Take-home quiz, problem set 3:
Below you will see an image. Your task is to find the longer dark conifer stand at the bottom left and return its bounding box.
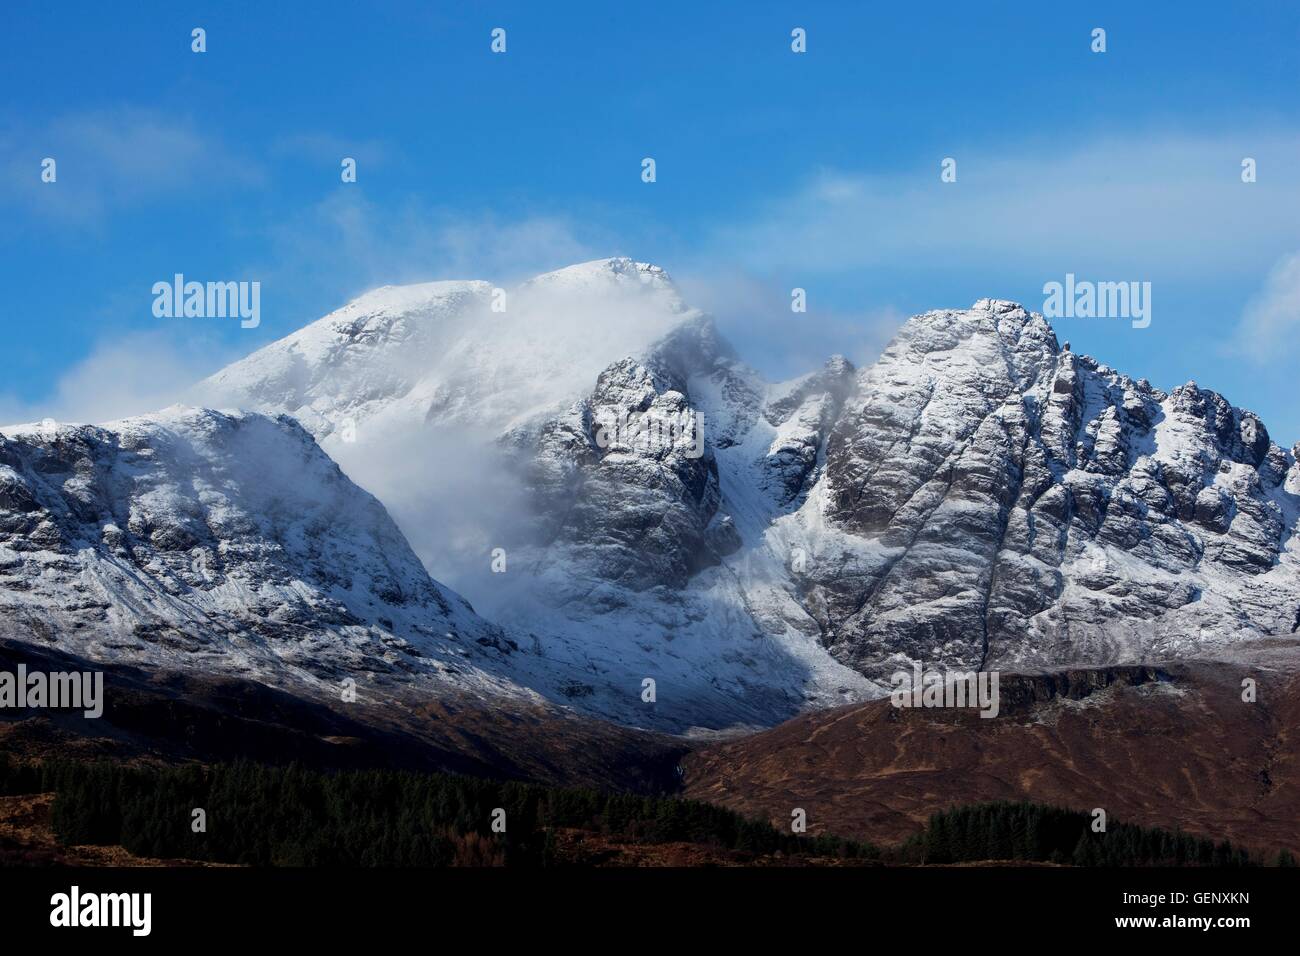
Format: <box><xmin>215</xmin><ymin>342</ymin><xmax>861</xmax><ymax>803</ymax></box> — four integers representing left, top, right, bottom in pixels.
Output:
<box><xmin>0</xmin><ymin>754</ymin><xmax>879</xmax><ymax>866</ymax></box>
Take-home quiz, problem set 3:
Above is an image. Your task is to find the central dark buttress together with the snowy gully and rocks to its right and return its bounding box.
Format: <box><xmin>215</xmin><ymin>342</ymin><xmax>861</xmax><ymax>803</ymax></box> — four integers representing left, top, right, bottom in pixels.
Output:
<box><xmin>507</xmin><ymin>316</ymin><xmax>854</xmax><ymax>600</ymax></box>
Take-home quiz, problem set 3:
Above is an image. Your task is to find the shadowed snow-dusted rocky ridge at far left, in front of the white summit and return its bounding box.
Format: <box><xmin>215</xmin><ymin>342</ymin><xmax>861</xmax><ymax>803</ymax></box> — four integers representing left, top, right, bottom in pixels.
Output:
<box><xmin>0</xmin><ymin>407</ymin><xmax>517</xmax><ymax>685</ymax></box>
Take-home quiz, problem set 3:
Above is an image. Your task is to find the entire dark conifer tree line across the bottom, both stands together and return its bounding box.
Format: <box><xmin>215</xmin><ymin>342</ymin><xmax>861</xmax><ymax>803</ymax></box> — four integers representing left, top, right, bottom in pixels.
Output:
<box><xmin>0</xmin><ymin>753</ymin><xmax>1296</xmax><ymax>866</ymax></box>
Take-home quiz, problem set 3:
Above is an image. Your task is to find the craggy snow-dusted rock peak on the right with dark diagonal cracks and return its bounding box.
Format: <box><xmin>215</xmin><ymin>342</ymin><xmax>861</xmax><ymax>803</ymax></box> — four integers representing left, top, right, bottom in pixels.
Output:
<box><xmin>806</xmin><ymin>300</ymin><xmax>1300</xmax><ymax>675</ymax></box>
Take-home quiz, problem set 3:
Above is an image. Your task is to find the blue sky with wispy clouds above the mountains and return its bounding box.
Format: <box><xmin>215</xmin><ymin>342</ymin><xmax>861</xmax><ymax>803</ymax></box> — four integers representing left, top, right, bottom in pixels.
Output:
<box><xmin>0</xmin><ymin>0</ymin><xmax>1300</xmax><ymax>445</ymax></box>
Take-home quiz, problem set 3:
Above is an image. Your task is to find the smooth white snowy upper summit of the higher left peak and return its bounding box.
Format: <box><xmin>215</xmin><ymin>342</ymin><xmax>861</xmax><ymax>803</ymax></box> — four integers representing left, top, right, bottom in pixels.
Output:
<box><xmin>194</xmin><ymin>260</ymin><xmax>692</xmax><ymax>444</ymax></box>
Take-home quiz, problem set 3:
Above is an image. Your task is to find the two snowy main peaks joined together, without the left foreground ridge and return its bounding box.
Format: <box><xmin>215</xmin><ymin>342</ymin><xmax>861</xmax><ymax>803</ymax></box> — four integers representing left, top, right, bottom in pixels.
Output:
<box><xmin>76</xmin><ymin>259</ymin><xmax>1300</xmax><ymax>731</ymax></box>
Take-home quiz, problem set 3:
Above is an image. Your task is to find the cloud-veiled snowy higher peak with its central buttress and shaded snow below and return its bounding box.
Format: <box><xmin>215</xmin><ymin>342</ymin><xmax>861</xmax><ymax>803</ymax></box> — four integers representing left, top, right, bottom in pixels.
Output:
<box><xmin>195</xmin><ymin>259</ymin><xmax>876</xmax><ymax>731</ymax></box>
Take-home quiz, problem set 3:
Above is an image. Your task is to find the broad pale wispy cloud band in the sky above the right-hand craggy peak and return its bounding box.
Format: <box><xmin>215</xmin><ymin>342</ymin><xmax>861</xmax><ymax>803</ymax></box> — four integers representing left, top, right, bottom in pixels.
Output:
<box><xmin>710</xmin><ymin>130</ymin><xmax>1300</xmax><ymax>278</ymax></box>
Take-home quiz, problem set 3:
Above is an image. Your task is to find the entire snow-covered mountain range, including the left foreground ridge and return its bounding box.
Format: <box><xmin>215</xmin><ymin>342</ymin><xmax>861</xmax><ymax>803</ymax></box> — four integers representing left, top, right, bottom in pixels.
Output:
<box><xmin>0</xmin><ymin>259</ymin><xmax>1300</xmax><ymax>731</ymax></box>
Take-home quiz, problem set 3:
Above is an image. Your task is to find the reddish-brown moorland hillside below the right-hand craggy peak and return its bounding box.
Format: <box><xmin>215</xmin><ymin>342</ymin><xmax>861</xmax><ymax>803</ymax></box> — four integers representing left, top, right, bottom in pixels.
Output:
<box><xmin>683</xmin><ymin>655</ymin><xmax>1300</xmax><ymax>852</ymax></box>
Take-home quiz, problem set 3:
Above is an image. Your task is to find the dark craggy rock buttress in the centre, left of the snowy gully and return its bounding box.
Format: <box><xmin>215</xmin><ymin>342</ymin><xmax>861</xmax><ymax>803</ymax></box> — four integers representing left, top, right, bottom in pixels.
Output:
<box><xmin>510</xmin><ymin>317</ymin><xmax>753</xmax><ymax>591</ymax></box>
